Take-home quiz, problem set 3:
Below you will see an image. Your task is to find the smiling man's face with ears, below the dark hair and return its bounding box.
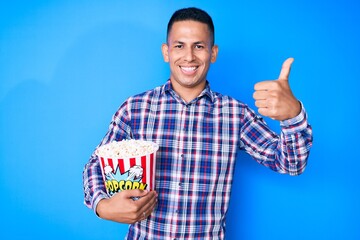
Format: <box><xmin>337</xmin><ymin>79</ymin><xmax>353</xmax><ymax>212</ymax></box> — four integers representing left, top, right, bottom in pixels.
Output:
<box><xmin>162</xmin><ymin>21</ymin><xmax>218</xmax><ymax>94</ymax></box>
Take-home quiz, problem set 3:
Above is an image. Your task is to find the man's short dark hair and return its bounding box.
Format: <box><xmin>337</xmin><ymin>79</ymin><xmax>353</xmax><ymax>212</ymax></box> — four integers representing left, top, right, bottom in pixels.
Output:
<box><xmin>166</xmin><ymin>7</ymin><xmax>215</xmax><ymax>45</ymax></box>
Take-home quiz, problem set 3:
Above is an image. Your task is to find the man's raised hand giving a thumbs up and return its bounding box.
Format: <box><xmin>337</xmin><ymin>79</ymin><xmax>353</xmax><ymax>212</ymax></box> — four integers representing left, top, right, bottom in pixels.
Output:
<box><xmin>253</xmin><ymin>58</ymin><xmax>301</xmax><ymax>121</ymax></box>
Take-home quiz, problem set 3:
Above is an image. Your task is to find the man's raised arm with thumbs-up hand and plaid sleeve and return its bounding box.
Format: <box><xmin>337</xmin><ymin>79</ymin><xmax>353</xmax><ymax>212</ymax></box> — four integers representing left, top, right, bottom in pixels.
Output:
<box><xmin>243</xmin><ymin>58</ymin><xmax>312</xmax><ymax>175</ymax></box>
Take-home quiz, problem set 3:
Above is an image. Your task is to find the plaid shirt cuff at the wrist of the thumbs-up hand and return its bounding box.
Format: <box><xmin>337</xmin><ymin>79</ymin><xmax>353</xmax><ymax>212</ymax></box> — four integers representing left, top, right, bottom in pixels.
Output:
<box><xmin>280</xmin><ymin>101</ymin><xmax>308</xmax><ymax>135</ymax></box>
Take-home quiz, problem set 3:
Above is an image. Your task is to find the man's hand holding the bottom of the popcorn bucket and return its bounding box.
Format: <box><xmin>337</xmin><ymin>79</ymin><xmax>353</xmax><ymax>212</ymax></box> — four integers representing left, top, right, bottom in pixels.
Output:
<box><xmin>96</xmin><ymin>189</ymin><xmax>157</xmax><ymax>224</ymax></box>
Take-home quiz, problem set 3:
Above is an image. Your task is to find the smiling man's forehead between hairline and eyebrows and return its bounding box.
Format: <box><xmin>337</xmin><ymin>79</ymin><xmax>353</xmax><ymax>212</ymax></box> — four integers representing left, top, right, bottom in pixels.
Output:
<box><xmin>168</xmin><ymin>20</ymin><xmax>210</xmax><ymax>42</ymax></box>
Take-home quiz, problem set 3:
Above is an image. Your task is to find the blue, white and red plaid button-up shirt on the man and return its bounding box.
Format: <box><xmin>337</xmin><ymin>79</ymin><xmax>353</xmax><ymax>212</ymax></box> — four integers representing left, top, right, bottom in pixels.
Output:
<box><xmin>83</xmin><ymin>81</ymin><xmax>312</xmax><ymax>239</ymax></box>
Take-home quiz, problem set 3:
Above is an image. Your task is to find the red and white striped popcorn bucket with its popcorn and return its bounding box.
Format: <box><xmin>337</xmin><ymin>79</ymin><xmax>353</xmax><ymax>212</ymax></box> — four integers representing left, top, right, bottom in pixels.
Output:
<box><xmin>95</xmin><ymin>140</ymin><xmax>159</xmax><ymax>197</ymax></box>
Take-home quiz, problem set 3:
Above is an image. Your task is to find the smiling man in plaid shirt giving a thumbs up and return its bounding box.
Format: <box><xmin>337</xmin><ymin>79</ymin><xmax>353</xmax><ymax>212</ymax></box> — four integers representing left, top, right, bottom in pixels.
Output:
<box><xmin>83</xmin><ymin>8</ymin><xmax>312</xmax><ymax>239</ymax></box>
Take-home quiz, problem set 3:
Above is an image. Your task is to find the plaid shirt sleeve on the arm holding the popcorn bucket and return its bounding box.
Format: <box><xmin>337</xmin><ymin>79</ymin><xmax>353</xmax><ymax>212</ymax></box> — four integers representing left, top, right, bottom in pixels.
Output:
<box><xmin>83</xmin><ymin>101</ymin><xmax>131</xmax><ymax>213</ymax></box>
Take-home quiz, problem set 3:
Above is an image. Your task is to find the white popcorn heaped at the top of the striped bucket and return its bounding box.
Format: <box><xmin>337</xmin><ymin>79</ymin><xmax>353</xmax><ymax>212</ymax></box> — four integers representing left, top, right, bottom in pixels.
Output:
<box><xmin>96</xmin><ymin>139</ymin><xmax>158</xmax><ymax>159</ymax></box>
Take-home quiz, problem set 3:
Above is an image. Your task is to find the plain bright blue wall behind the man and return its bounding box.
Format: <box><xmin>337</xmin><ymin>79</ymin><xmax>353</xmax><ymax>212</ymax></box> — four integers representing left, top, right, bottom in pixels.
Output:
<box><xmin>0</xmin><ymin>0</ymin><xmax>360</xmax><ymax>240</ymax></box>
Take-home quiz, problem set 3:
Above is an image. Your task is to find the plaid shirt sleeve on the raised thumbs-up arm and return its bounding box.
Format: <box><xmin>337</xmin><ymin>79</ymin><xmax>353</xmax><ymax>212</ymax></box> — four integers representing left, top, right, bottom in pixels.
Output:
<box><xmin>241</xmin><ymin>104</ymin><xmax>313</xmax><ymax>176</ymax></box>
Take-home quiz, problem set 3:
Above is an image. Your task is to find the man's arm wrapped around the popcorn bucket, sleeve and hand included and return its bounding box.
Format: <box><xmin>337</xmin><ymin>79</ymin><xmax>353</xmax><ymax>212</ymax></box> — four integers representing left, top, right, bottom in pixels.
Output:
<box><xmin>83</xmin><ymin>104</ymin><xmax>157</xmax><ymax>223</ymax></box>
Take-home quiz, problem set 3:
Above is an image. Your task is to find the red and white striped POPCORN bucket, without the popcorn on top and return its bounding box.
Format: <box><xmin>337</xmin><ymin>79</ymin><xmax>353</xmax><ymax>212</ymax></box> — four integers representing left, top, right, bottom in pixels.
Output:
<box><xmin>98</xmin><ymin>143</ymin><xmax>159</xmax><ymax>196</ymax></box>
